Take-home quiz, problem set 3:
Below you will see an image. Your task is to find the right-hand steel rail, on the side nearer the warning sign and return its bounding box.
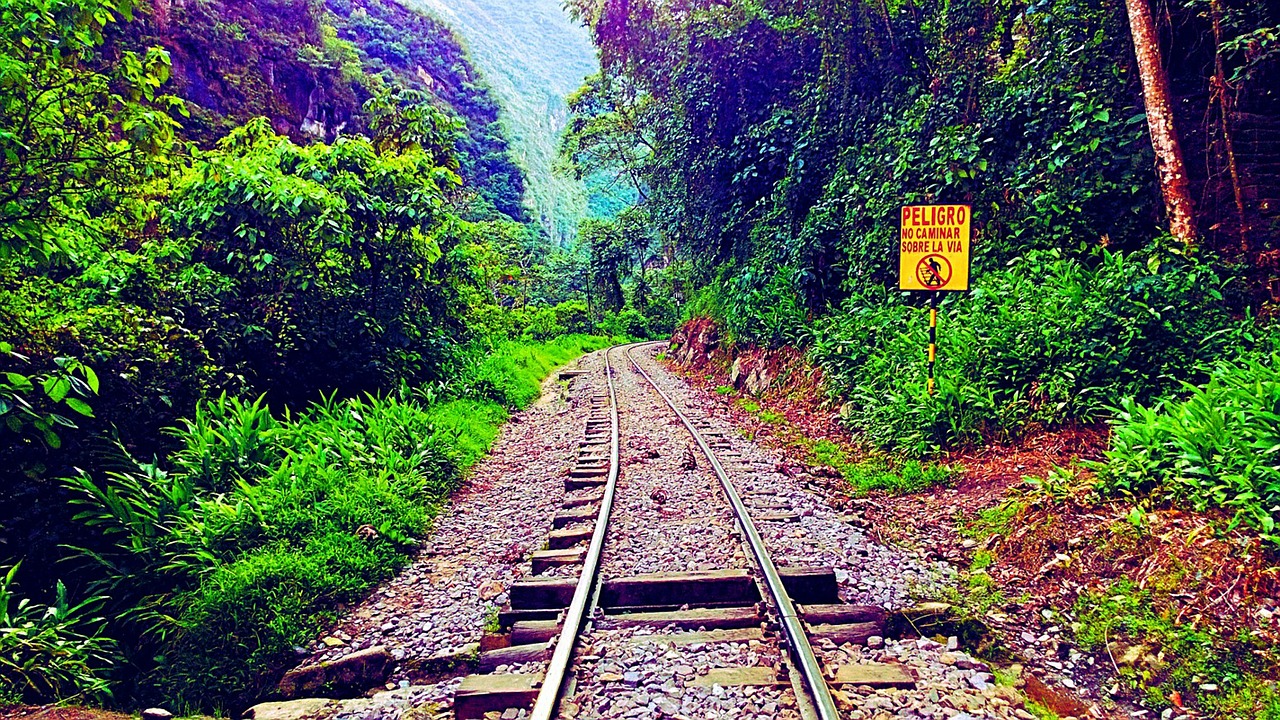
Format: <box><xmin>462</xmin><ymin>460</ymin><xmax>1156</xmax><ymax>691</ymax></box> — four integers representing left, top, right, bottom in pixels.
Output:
<box><xmin>624</xmin><ymin>343</ymin><xmax>840</xmax><ymax>720</ymax></box>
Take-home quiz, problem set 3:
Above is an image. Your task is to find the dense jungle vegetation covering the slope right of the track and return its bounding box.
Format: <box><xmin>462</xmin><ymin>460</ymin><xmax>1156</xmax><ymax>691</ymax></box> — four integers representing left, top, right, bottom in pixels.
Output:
<box><xmin>564</xmin><ymin>0</ymin><xmax>1280</xmax><ymax>542</ymax></box>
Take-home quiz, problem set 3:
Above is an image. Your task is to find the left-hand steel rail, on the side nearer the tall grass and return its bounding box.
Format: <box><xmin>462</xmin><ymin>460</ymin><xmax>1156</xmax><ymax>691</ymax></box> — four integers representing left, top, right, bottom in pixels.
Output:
<box><xmin>529</xmin><ymin>346</ymin><xmax>630</xmax><ymax>720</ymax></box>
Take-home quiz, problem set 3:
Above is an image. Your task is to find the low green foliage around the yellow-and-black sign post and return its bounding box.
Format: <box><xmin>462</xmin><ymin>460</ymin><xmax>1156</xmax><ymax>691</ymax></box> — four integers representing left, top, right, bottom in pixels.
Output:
<box><xmin>810</xmin><ymin>243</ymin><xmax>1248</xmax><ymax>454</ymax></box>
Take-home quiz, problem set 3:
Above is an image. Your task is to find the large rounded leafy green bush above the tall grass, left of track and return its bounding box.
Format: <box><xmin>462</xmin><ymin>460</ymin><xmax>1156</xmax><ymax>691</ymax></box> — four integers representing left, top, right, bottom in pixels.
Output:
<box><xmin>170</xmin><ymin>114</ymin><xmax>461</xmax><ymax>402</ymax></box>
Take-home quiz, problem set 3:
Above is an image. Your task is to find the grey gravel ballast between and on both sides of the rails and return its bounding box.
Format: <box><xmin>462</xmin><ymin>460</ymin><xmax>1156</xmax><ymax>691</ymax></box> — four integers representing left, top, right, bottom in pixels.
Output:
<box><xmin>294</xmin><ymin>347</ymin><xmax>1032</xmax><ymax>720</ymax></box>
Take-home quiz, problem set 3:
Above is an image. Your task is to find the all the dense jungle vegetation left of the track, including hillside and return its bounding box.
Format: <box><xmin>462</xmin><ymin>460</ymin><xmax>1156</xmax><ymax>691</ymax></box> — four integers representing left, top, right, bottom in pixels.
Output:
<box><xmin>0</xmin><ymin>0</ymin><xmax>675</xmax><ymax>711</ymax></box>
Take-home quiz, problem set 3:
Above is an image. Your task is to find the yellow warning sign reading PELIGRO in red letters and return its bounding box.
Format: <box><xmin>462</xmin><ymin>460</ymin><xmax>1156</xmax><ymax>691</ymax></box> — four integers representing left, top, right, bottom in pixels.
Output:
<box><xmin>897</xmin><ymin>205</ymin><xmax>973</xmax><ymax>290</ymax></box>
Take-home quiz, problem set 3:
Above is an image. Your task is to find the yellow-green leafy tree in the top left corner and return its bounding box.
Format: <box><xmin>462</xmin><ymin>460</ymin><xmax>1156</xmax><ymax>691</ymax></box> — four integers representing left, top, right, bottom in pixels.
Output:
<box><xmin>0</xmin><ymin>0</ymin><xmax>186</xmax><ymax>258</ymax></box>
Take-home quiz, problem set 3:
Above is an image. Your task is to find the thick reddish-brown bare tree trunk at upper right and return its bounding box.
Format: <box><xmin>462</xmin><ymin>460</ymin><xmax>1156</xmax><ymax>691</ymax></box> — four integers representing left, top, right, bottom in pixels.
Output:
<box><xmin>1125</xmin><ymin>0</ymin><xmax>1196</xmax><ymax>246</ymax></box>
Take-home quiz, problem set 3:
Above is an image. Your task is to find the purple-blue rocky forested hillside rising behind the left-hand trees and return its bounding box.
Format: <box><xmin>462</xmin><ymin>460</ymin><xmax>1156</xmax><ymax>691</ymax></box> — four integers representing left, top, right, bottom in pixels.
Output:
<box><xmin>106</xmin><ymin>0</ymin><xmax>526</xmax><ymax>220</ymax></box>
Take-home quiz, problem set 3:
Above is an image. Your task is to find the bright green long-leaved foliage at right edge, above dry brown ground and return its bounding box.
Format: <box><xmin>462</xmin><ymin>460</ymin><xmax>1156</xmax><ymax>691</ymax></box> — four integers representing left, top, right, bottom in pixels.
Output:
<box><xmin>1097</xmin><ymin>340</ymin><xmax>1280</xmax><ymax>543</ymax></box>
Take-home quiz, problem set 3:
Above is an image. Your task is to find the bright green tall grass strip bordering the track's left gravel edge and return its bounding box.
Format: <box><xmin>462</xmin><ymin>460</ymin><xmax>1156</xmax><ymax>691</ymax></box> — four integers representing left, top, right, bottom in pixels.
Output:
<box><xmin>45</xmin><ymin>336</ymin><xmax>608</xmax><ymax>710</ymax></box>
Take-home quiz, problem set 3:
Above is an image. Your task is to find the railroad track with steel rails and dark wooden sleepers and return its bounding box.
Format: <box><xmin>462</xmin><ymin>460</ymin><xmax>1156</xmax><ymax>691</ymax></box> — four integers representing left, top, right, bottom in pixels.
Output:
<box><xmin>454</xmin><ymin>343</ymin><xmax>913</xmax><ymax>720</ymax></box>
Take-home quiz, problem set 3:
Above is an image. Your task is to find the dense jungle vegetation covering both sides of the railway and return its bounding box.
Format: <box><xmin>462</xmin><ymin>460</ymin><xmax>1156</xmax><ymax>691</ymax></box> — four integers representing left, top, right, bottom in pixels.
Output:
<box><xmin>0</xmin><ymin>0</ymin><xmax>1280</xmax><ymax>711</ymax></box>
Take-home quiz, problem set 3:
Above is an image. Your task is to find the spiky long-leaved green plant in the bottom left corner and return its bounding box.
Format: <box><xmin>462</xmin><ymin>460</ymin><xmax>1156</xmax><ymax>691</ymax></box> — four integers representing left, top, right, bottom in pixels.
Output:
<box><xmin>0</xmin><ymin>565</ymin><xmax>118</xmax><ymax>703</ymax></box>
